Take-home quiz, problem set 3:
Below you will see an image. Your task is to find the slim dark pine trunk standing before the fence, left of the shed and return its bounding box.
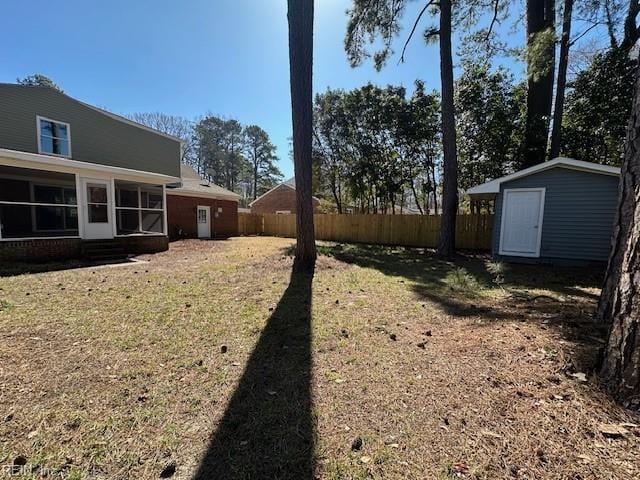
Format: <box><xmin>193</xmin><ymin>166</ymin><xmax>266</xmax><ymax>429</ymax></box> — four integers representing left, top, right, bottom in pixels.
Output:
<box><xmin>438</xmin><ymin>0</ymin><xmax>458</xmax><ymax>257</ymax></box>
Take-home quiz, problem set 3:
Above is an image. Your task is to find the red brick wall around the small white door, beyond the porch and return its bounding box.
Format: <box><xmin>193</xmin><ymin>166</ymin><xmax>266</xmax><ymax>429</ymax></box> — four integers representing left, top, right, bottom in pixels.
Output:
<box><xmin>167</xmin><ymin>195</ymin><xmax>238</xmax><ymax>240</ymax></box>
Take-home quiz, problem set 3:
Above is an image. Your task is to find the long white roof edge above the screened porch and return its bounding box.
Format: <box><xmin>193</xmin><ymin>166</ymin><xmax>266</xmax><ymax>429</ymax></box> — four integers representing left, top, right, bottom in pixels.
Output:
<box><xmin>0</xmin><ymin>148</ymin><xmax>180</xmax><ymax>185</ymax></box>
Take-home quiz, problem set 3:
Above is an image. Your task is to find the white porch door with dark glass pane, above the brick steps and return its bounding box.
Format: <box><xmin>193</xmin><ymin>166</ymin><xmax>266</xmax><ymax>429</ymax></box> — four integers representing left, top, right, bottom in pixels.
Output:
<box><xmin>80</xmin><ymin>178</ymin><xmax>113</xmax><ymax>240</ymax></box>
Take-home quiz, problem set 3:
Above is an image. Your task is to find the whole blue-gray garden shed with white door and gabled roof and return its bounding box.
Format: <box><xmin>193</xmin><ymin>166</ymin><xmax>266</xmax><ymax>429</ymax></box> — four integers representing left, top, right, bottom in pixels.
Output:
<box><xmin>467</xmin><ymin>158</ymin><xmax>620</xmax><ymax>264</ymax></box>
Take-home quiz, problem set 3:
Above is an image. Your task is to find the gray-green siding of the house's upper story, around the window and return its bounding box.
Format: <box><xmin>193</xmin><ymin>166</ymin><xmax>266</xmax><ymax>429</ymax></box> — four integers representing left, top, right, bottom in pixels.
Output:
<box><xmin>0</xmin><ymin>84</ymin><xmax>180</xmax><ymax>177</ymax></box>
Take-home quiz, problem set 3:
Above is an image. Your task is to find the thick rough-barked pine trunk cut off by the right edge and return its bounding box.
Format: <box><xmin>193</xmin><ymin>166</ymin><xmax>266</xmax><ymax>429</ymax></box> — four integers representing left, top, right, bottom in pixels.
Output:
<box><xmin>598</xmin><ymin>57</ymin><xmax>640</xmax><ymax>408</ymax></box>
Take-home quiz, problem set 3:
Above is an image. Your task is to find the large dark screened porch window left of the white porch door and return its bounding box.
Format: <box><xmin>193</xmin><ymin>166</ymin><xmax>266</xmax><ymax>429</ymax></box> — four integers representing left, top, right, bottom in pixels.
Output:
<box><xmin>0</xmin><ymin>167</ymin><xmax>78</xmax><ymax>239</ymax></box>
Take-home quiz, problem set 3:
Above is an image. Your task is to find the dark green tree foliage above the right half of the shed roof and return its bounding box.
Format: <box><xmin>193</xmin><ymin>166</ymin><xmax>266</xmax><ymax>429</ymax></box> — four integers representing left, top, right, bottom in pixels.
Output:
<box><xmin>561</xmin><ymin>48</ymin><xmax>636</xmax><ymax>165</ymax></box>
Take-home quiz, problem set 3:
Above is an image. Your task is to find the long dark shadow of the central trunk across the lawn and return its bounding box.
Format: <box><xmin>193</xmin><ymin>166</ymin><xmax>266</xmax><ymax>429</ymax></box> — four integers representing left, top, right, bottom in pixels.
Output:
<box><xmin>193</xmin><ymin>266</ymin><xmax>315</xmax><ymax>480</ymax></box>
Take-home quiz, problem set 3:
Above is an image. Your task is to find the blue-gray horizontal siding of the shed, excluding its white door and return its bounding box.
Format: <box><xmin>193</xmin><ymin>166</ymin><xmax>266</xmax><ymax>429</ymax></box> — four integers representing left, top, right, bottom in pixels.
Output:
<box><xmin>493</xmin><ymin>167</ymin><xmax>619</xmax><ymax>263</ymax></box>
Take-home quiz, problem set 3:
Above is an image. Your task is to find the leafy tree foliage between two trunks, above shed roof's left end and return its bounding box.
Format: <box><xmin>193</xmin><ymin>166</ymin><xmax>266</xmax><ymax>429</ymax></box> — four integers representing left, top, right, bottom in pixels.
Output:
<box><xmin>455</xmin><ymin>60</ymin><xmax>526</xmax><ymax>189</ymax></box>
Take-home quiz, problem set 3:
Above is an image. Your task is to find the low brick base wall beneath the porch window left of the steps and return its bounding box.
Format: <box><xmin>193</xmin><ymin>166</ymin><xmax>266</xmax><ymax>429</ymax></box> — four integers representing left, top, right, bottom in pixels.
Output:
<box><xmin>0</xmin><ymin>238</ymin><xmax>82</xmax><ymax>262</ymax></box>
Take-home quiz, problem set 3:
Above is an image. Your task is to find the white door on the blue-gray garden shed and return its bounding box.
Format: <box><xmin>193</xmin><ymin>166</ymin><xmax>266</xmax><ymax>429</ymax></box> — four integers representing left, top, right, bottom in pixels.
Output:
<box><xmin>500</xmin><ymin>188</ymin><xmax>545</xmax><ymax>257</ymax></box>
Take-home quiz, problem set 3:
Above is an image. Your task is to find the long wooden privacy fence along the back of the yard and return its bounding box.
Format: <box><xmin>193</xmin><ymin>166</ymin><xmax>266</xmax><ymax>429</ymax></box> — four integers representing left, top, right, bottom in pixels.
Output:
<box><xmin>238</xmin><ymin>213</ymin><xmax>493</xmax><ymax>250</ymax></box>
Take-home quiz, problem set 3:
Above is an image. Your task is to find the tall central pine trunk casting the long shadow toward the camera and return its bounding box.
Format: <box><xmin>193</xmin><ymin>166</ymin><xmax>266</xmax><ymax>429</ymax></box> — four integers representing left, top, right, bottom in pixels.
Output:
<box><xmin>288</xmin><ymin>0</ymin><xmax>317</xmax><ymax>270</ymax></box>
